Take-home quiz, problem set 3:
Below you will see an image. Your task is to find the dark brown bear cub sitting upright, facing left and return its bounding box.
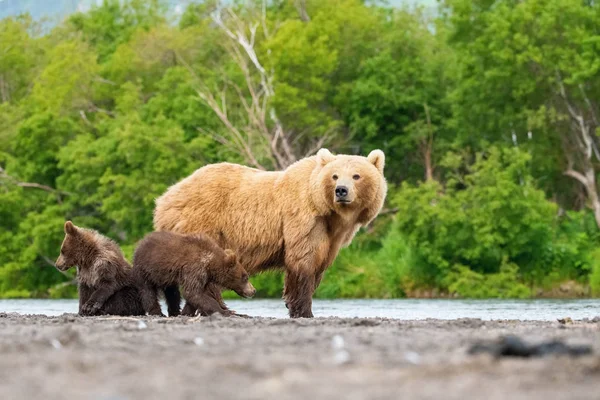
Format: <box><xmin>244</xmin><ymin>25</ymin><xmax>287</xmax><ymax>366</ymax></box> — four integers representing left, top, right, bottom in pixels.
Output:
<box><xmin>55</xmin><ymin>221</ymin><xmax>144</xmax><ymax>316</ymax></box>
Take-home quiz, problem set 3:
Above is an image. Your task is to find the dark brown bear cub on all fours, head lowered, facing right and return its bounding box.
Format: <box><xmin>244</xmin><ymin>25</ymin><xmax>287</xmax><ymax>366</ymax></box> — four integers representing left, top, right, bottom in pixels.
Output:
<box><xmin>133</xmin><ymin>232</ymin><xmax>256</xmax><ymax>316</ymax></box>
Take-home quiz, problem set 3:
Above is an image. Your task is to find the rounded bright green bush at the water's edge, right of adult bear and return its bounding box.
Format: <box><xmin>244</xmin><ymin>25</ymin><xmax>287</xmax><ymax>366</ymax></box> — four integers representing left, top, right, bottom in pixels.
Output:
<box><xmin>392</xmin><ymin>148</ymin><xmax>557</xmax><ymax>297</ymax></box>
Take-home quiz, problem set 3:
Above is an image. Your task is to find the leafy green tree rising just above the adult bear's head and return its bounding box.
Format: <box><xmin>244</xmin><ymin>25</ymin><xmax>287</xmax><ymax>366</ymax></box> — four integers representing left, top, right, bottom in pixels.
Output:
<box><xmin>342</xmin><ymin>10</ymin><xmax>454</xmax><ymax>180</ymax></box>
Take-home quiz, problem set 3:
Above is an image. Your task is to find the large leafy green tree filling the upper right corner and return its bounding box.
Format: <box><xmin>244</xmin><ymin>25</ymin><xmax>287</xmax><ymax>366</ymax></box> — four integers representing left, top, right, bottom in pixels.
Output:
<box><xmin>446</xmin><ymin>0</ymin><xmax>600</xmax><ymax>227</ymax></box>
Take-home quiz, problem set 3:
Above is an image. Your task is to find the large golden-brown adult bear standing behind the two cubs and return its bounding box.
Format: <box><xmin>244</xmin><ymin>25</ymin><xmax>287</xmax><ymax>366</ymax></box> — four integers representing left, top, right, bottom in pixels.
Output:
<box><xmin>154</xmin><ymin>149</ymin><xmax>387</xmax><ymax>318</ymax></box>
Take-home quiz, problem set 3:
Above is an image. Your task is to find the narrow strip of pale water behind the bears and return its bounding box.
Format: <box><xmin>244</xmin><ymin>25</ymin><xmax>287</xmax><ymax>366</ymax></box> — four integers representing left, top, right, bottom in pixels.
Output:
<box><xmin>0</xmin><ymin>299</ymin><xmax>600</xmax><ymax>321</ymax></box>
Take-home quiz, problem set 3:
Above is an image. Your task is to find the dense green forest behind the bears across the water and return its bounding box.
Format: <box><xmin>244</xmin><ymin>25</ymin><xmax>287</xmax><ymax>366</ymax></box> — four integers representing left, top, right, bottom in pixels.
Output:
<box><xmin>0</xmin><ymin>0</ymin><xmax>600</xmax><ymax>298</ymax></box>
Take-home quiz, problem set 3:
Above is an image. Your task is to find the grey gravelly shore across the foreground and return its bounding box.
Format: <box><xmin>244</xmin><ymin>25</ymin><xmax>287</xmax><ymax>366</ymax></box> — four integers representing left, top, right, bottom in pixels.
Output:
<box><xmin>0</xmin><ymin>313</ymin><xmax>600</xmax><ymax>400</ymax></box>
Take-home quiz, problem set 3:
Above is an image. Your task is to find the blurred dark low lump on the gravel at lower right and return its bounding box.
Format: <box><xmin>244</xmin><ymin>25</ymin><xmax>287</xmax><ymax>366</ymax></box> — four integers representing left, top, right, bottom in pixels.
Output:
<box><xmin>468</xmin><ymin>336</ymin><xmax>593</xmax><ymax>358</ymax></box>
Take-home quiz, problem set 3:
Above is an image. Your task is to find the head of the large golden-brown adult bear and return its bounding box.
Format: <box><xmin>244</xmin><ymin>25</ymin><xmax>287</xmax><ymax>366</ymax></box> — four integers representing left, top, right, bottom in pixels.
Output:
<box><xmin>311</xmin><ymin>149</ymin><xmax>387</xmax><ymax>214</ymax></box>
